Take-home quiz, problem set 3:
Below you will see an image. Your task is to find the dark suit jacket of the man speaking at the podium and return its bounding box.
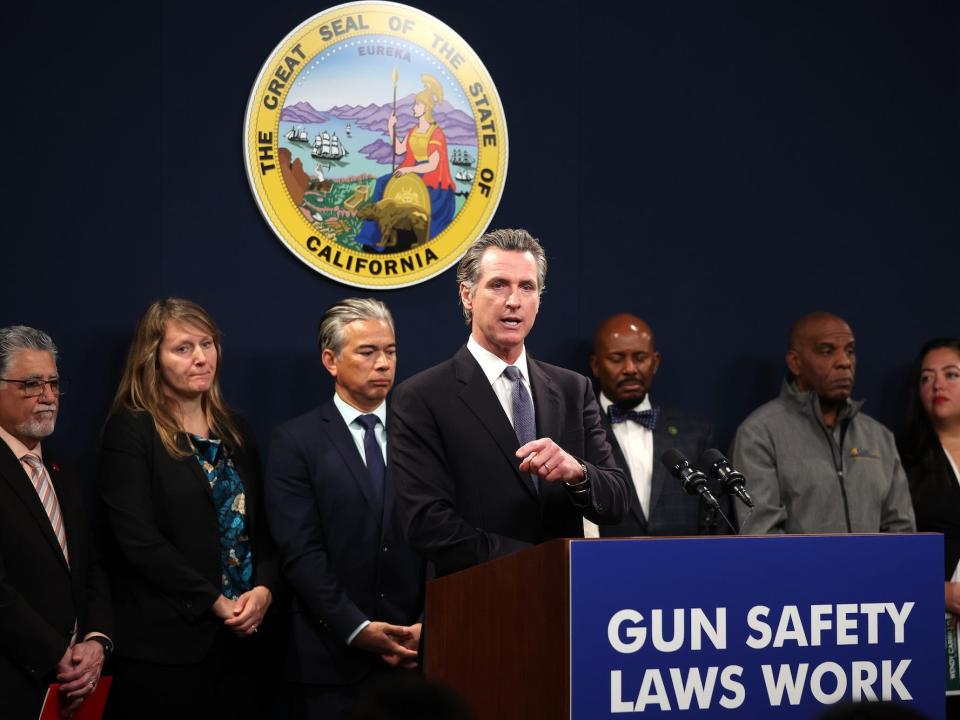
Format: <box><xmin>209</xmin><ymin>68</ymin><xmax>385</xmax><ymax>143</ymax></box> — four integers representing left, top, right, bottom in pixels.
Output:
<box><xmin>390</xmin><ymin>347</ymin><xmax>627</xmax><ymax>575</ymax></box>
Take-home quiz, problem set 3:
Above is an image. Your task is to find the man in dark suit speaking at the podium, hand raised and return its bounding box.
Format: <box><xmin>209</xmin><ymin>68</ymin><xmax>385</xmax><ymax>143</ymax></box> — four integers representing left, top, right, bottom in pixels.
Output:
<box><xmin>389</xmin><ymin>230</ymin><xmax>628</xmax><ymax>575</ymax></box>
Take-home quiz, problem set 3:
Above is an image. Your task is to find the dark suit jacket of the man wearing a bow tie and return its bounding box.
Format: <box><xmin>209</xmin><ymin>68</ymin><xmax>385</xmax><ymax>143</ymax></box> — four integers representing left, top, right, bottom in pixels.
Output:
<box><xmin>600</xmin><ymin>407</ymin><xmax>732</xmax><ymax>537</ymax></box>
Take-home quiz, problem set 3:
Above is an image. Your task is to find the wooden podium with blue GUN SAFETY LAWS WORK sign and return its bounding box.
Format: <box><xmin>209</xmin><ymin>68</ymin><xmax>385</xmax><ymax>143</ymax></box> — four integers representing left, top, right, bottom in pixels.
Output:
<box><xmin>424</xmin><ymin>534</ymin><xmax>945</xmax><ymax>720</ymax></box>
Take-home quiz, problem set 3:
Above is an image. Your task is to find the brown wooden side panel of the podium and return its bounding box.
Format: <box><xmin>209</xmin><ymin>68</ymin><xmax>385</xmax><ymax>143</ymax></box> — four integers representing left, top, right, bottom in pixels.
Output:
<box><xmin>424</xmin><ymin>540</ymin><xmax>570</xmax><ymax>720</ymax></box>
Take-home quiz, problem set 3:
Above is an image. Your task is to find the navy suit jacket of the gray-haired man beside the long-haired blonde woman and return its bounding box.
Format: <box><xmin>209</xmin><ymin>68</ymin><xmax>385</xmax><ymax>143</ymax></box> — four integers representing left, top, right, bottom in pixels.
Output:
<box><xmin>266</xmin><ymin>400</ymin><xmax>424</xmax><ymax>686</ymax></box>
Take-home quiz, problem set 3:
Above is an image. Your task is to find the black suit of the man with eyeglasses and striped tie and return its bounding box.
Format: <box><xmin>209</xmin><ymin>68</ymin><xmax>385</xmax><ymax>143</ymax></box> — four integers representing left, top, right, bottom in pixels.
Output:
<box><xmin>0</xmin><ymin>440</ymin><xmax>113</xmax><ymax>720</ymax></box>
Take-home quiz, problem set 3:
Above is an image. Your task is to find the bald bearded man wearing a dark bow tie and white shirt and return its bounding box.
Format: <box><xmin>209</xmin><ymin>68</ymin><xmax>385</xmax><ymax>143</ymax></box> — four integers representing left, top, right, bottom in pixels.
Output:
<box><xmin>584</xmin><ymin>313</ymin><xmax>732</xmax><ymax>537</ymax></box>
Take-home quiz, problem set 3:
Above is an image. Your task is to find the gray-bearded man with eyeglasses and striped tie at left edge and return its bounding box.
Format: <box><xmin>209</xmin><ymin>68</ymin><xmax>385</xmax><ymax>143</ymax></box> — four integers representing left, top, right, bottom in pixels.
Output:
<box><xmin>0</xmin><ymin>325</ymin><xmax>113</xmax><ymax>718</ymax></box>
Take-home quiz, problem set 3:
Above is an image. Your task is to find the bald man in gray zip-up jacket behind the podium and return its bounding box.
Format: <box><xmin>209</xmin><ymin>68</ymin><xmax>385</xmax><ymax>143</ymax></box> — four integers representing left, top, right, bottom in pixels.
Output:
<box><xmin>731</xmin><ymin>313</ymin><xmax>916</xmax><ymax>535</ymax></box>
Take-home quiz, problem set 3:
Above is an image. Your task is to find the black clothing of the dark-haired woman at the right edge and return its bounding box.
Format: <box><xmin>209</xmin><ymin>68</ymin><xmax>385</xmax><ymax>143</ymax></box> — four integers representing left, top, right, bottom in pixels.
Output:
<box><xmin>907</xmin><ymin>446</ymin><xmax>960</xmax><ymax>580</ymax></box>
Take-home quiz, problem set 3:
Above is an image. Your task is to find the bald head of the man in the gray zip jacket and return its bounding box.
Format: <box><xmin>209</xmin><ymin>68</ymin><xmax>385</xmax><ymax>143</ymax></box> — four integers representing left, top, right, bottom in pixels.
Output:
<box><xmin>786</xmin><ymin>312</ymin><xmax>857</xmax><ymax>406</ymax></box>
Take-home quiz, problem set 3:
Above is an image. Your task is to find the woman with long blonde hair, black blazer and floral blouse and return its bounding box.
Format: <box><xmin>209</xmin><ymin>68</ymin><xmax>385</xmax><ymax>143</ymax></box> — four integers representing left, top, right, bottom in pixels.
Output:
<box><xmin>98</xmin><ymin>298</ymin><xmax>277</xmax><ymax>720</ymax></box>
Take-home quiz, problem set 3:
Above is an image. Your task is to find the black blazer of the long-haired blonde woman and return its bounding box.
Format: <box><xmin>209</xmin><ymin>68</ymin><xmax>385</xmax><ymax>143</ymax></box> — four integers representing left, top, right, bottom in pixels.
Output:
<box><xmin>98</xmin><ymin>410</ymin><xmax>278</xmax><ymax>664</ymax></box>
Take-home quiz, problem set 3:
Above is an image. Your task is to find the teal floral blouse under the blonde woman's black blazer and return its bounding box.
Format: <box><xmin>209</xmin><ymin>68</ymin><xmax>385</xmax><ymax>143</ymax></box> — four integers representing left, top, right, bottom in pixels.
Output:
<box><xmin>190</xmin><ymin>434</ymin><xmax>253</xmax><ymax>600</ymax></box>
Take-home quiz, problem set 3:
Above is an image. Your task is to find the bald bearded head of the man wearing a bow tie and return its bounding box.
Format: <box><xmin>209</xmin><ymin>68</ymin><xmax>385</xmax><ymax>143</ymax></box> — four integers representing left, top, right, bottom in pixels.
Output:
<box><xmin>590</xmin><ymin>313</ymin><xmax>660</xmax><ymax>408</ymax></box>
